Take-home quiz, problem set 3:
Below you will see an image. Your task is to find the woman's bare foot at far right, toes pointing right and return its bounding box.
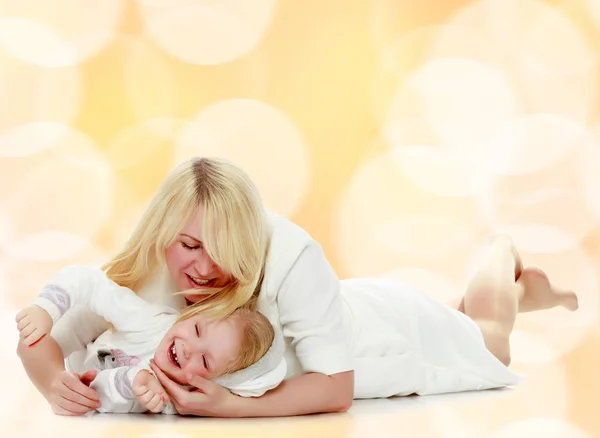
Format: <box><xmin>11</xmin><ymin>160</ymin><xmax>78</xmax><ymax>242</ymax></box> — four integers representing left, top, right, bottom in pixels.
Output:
<box><xmin>518</xmin><ymin>268</ymin><xmax>579</xmax><ymax>313</ymax></box>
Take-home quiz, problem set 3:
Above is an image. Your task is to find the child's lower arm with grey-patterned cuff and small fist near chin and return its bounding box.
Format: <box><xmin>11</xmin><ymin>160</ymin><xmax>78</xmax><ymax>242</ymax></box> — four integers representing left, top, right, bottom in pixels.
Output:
<box><xmin>90</xmin><ymin>366</ymin><xmax>177</xmax><ymax>414</ymax></box>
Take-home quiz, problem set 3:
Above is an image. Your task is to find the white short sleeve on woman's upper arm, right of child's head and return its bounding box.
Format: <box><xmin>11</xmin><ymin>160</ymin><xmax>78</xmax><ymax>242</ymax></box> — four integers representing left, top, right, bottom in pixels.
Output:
<box><xmin>277</xmin><ymin>243</ymin><xmax>353</xmax><ymax>375</ymax></box>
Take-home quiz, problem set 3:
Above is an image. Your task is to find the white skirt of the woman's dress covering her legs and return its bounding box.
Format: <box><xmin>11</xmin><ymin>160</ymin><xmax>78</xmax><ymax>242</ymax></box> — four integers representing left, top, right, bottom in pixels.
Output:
<box><xmin>341</xmin><ymin>279</ymin><xmax>521</xmax><ymax>398</ymax></box>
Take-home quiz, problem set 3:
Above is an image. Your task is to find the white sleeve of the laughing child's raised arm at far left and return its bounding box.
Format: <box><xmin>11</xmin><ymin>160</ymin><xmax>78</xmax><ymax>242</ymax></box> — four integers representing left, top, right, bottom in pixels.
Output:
<box><xmin>33</xmin><ymin>266</ymin><xmax>172</xmax><ymax>331</ymax></box>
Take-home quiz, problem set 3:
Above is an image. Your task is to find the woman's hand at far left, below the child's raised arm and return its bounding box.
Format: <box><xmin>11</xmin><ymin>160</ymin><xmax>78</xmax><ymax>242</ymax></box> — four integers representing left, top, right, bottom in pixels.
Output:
<box><xmin>44</xmin><ymin>370</ymin><xmax>100</xmax><ymax>415</ymax></box>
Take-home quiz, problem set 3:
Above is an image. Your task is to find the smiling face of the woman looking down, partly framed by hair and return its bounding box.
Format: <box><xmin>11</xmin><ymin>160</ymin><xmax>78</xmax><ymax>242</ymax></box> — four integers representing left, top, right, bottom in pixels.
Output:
<box><xmin>166</xmin><ymin>207</ymin><xmax>231</xmax><ymax>302</ymax></box>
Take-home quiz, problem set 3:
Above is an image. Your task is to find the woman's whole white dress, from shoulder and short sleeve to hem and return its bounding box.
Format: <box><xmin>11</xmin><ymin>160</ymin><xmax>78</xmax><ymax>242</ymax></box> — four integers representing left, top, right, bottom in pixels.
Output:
<box><xmin>47</xmin><ymin>215</ymin><xmax>520</xmax><ymax>404</ymax></box>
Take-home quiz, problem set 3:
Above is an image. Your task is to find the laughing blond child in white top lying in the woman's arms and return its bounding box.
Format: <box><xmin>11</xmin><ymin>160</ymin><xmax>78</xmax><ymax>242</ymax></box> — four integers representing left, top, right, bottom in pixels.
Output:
<box><xmin>16</xmin><ymin>266</ymin><xmax>286</xmax><ymax>414</ymax></box>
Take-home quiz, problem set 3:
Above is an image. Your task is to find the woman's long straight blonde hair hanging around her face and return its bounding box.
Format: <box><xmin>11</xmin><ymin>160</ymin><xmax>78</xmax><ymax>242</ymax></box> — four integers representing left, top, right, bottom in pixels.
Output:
<box><xmin>103</xmin><ymin>158</ymin><xmax>271</xmax><ymax>317</ymax></box>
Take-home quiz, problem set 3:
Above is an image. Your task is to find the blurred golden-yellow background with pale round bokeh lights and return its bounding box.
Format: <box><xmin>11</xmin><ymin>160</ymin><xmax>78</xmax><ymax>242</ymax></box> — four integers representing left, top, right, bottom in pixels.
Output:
<box><xmin>0</xmin><ymin>0</ymin><xmax>600</xmax><ymax>437</ymax></box>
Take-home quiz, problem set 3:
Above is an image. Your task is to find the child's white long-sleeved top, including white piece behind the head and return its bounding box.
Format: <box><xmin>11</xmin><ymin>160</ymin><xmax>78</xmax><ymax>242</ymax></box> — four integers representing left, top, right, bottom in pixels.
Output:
<box><xmin>33</xmin><ymin>266</ymin><xmax>286</xmax><ymax>414</ymax></box>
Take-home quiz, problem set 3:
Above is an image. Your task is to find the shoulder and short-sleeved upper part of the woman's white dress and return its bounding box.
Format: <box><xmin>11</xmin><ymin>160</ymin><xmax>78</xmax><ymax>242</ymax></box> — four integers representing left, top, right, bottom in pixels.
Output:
<box><xmin>257</xmin><ymin>215</ymin><xmax>353</xmax><ymax>378</ymax></box>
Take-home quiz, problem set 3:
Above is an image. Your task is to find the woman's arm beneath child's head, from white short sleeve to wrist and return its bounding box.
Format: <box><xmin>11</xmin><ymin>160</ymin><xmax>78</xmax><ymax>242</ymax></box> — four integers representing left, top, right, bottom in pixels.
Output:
<box><xmin>258</xmin><ymin>243</ymin><xmax>354</xmax><ymax>416</ymax></box>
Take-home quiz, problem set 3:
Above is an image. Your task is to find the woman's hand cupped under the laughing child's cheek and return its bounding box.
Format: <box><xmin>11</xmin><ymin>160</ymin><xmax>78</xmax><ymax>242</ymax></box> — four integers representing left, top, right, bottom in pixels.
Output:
<box><xmin>150</xmin><ymin>361</ymin><xmax>238</xmax><ymax>417</ymax></box>
